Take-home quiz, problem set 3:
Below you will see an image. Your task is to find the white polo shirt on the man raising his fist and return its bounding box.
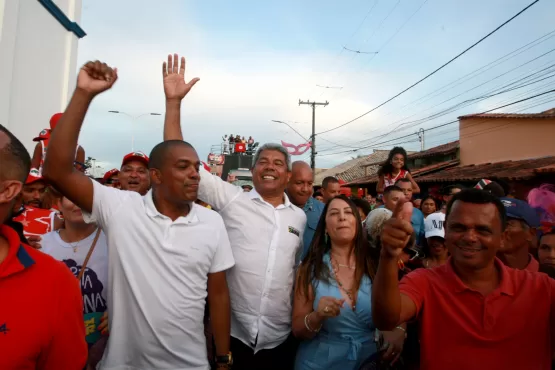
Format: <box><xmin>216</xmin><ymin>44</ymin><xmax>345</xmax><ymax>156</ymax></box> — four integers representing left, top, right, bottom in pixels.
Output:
<box><xmin>85</xmin><ymin>181</ymin><xmax>235</xmax><ymax>370</ymax></box>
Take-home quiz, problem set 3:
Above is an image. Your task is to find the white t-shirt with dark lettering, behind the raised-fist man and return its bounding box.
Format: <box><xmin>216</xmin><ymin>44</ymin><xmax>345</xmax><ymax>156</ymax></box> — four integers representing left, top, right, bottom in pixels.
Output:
<box><xmin>41</xmin><ymin>231</ymin><xmax>108</xmax><ymax>344</ymax></box>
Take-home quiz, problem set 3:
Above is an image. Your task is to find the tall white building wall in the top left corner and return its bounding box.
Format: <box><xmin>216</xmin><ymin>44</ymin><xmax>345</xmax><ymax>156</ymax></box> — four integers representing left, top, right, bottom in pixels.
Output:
<box><xmin>0</xmin><ymin>0</ymin><xmax>82</xmax><ymax>154</ymax></box>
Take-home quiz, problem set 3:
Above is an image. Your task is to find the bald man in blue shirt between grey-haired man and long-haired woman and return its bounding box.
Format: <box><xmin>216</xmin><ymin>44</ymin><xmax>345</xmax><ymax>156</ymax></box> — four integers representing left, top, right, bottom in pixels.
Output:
<box><xmin>286</xmin><ymin>161</ymin><xmax>324</xmax><ymax>260</ymax></box>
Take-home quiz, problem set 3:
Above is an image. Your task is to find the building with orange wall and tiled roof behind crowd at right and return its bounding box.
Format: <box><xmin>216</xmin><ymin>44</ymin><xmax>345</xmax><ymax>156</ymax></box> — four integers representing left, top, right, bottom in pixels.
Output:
<box><xmin>348</xmin><ymin>108</ymin><xmax>555</xmax><ymax>198</ymax></box>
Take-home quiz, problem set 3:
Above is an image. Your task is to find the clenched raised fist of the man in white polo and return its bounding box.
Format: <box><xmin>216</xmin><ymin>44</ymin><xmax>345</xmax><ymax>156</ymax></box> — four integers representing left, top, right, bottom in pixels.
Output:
<box><xmin>77</xmin><ymin>60</ymin><xmax>118</xmax><ymax>96</ymax></box>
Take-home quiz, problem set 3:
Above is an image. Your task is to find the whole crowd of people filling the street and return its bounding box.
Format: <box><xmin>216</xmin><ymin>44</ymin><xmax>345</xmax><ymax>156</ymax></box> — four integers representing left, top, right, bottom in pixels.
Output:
<box><xmin>0</xmin><ymin>55</ymin><xmax>555</xmax><ymax>370</ymax></box>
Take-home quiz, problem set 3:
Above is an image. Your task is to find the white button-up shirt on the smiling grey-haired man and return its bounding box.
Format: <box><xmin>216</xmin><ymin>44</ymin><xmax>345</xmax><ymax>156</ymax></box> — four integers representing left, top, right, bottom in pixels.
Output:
<box><xmin>198</xmin><ymin>168</ymin><xmax>306</xmax><ymax>353</ymax></box>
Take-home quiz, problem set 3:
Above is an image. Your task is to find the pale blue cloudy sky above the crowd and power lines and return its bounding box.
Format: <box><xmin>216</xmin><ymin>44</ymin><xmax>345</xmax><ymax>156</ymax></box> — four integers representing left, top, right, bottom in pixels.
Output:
<box><xmin>76</xmin><ymin>0</ymin><xmax>555</xmax><ymax>171</ymax></box>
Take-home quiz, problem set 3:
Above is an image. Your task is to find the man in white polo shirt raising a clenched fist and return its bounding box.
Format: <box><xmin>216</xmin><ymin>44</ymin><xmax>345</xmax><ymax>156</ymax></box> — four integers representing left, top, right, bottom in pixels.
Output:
<box><xmin>44</xmin><ymin>61</ymin><xmax>235</xmax><ymax>370</ymax></box>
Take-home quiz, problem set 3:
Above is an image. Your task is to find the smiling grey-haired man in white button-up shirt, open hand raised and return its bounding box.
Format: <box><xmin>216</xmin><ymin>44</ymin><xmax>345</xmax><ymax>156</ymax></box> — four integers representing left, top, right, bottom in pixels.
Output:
<box><xmin>164</xmin><ymin>54</ymin><xmax>306</xmax><ymax>370</ymax></box>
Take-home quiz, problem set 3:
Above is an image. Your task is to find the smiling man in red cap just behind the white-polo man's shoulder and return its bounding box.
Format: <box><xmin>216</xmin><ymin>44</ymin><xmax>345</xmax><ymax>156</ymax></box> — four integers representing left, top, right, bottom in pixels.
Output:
<box><xmin>118</xmin><ymin>152</ymin><xmax>150</xmax><ymax>195</ymax></box>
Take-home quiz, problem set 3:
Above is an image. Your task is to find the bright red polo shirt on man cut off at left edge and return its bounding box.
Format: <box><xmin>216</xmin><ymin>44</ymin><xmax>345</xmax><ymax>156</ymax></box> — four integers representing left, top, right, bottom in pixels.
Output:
<box><xmin>0</xmin><ymin>225</ymin><xmax>87</xmax><ymax>370</ymax></box>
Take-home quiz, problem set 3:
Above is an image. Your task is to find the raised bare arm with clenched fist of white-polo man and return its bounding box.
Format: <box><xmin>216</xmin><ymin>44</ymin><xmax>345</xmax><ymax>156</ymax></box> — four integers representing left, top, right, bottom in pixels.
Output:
<box><xmin>43</xmin><ymin>61</ymin><xmax>118</xmax><ymax>213</ymax></box>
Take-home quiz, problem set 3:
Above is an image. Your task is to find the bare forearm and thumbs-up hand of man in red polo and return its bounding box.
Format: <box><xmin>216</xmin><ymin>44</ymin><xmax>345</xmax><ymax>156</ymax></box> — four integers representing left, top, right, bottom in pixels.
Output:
<box><xmin>372</xmin><ymin>202</ymin><xmax>416</xmax><ymax>330</ymax></box>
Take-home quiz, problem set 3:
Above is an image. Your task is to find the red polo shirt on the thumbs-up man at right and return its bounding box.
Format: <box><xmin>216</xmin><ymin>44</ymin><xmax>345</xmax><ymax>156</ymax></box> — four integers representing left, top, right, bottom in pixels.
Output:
<box><xmin>399</xmin><ymin>259</ymin><xmax>555</xmax><ymax>370</ymax></box>
